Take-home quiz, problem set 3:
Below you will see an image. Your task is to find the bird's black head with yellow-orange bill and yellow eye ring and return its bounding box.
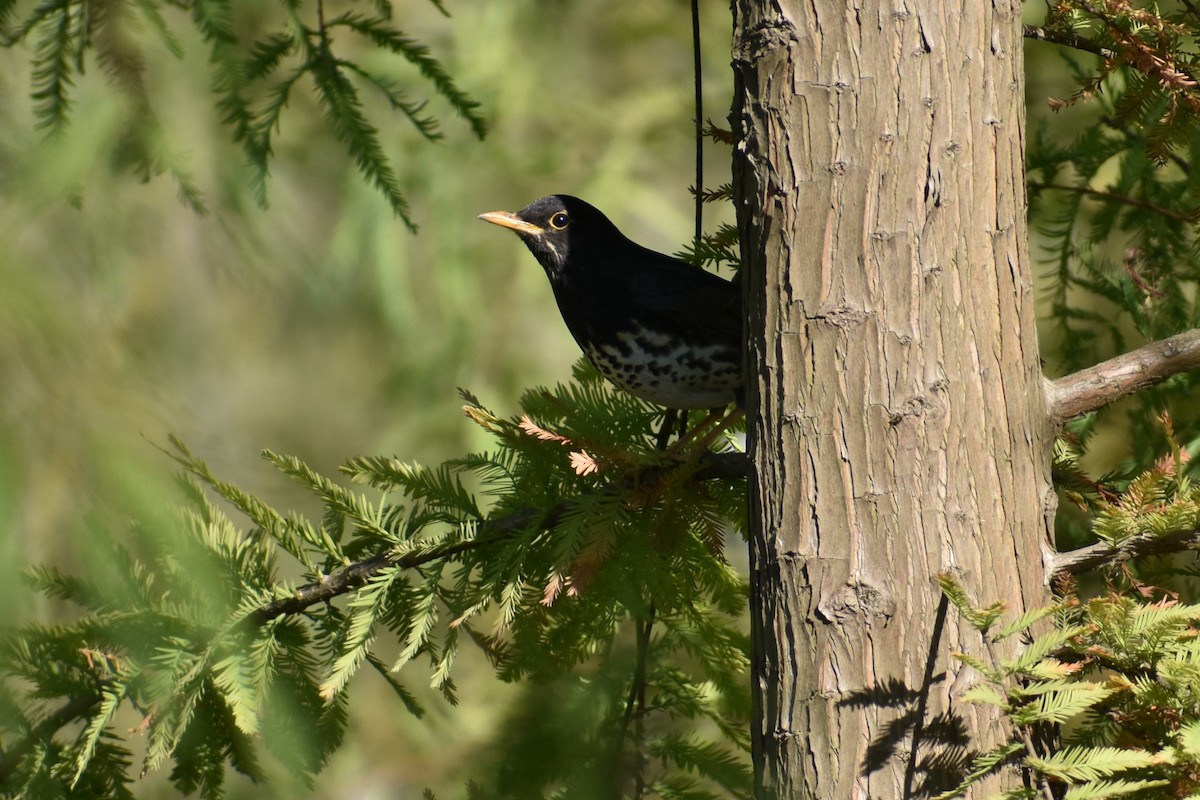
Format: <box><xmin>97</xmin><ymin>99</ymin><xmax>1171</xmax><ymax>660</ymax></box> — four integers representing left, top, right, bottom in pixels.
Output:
<box><xmin>479</xmin><ymin>194</ymin><xmax>625</xmax><ymax>279</ymax></box>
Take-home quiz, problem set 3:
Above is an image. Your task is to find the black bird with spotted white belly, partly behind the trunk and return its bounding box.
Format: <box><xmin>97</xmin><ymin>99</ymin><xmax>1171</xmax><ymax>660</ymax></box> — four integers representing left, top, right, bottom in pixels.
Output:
<box><xmin>479</xmin><ymin>194</ymin><xmax>743</xmax><ymax>409</ymax></box>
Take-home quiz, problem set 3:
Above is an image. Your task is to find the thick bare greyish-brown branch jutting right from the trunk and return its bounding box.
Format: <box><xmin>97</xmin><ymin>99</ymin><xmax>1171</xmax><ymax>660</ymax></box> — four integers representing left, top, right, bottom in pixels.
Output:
<box><xmin>1045</xmin><ymin>329</ymin><xmax>1200</xmax><ymax>426</ymax></box>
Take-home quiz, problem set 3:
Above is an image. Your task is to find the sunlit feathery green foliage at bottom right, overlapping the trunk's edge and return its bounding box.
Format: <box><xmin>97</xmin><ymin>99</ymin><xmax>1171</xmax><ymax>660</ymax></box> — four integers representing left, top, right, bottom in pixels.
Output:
<box><xmin>938</xmin><ymin>575</ymin><xmax>1200</xmax><ymax>800</ymax></box>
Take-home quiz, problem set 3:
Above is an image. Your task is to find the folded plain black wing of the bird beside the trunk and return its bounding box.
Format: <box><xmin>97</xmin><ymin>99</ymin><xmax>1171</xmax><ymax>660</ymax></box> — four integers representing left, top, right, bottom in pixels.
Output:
<box><xmin>632</xmin><ymin>248</ymin><xmax>742</xmax><ymax>345</ymax></box>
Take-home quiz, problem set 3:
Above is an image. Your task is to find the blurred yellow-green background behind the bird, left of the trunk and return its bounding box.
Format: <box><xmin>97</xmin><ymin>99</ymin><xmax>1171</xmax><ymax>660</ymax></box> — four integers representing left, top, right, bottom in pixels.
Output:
<box><xmin>0</xmin><ymin>0</ymin><xmax>732</xmax><ymax>798</ymax></box>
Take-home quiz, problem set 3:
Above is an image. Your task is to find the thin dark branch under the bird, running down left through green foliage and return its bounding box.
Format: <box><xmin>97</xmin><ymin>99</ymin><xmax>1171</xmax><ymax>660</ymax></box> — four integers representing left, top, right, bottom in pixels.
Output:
<box><xmin>250</xmin><ymin>452</ymin><xmax>749</xmax><ymax>625</ymax></box>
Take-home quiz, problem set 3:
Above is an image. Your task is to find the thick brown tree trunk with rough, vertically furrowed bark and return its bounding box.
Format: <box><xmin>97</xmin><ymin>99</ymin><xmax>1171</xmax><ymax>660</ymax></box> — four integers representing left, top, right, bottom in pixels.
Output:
<box><xmin>733</xmin><ymin>0</ymin><xmax>1052</xmax><ymax>800</ymax></box>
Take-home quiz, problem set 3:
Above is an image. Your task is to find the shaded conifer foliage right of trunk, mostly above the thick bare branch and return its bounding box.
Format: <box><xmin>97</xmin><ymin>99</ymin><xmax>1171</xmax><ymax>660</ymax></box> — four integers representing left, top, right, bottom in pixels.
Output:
<box><xmin>1026</xmin><ymin>0</ymin><xmax>1200</xmax><ymax>470</ymax></box>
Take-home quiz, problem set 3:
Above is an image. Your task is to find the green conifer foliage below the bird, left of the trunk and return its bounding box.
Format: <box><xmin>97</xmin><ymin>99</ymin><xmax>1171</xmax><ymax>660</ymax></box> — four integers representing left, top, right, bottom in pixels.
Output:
<box><xmin>0</xmin><ymin>363</ymin><xmax>750</xmax><ymax>798</ymax></box>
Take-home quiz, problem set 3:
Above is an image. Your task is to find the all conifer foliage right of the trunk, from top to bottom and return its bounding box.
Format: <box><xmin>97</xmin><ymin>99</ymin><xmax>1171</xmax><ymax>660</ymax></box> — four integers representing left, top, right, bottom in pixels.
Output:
<box><xmin>921</xmin><ymin>0</ymin><xmax>1200</xmax><ymax>800</ymax></box>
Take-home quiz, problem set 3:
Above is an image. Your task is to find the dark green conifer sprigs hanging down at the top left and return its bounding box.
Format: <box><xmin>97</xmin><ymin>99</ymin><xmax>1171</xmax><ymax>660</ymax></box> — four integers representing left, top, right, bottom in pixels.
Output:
<box><xmin>0</xmin><ymin>0</ymin><xmax>487</xmax><ymax>225</ymax></box>
